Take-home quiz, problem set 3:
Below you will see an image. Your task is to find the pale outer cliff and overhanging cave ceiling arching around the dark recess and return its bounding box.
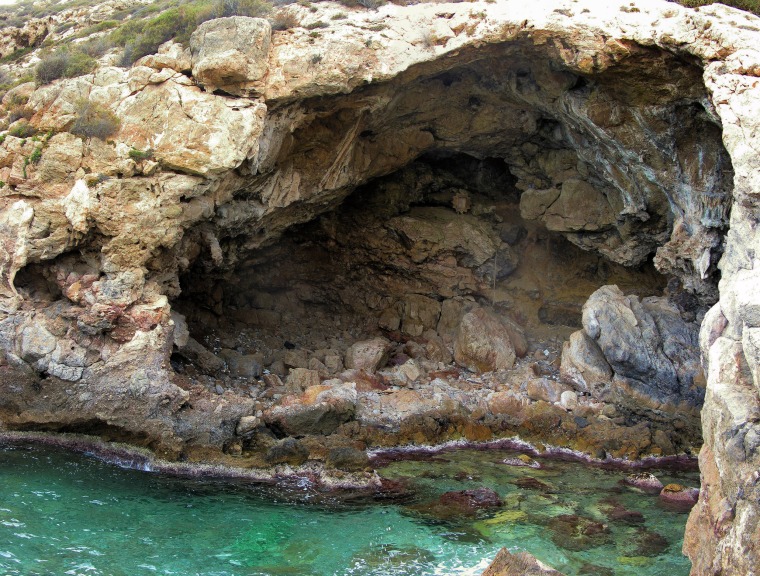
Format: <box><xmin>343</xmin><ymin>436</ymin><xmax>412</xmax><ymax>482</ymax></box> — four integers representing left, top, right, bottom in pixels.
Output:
<box><xmin>0</xmin><ymin>0</ymin><xmax>760</xmax><ymax>574</ymax></box>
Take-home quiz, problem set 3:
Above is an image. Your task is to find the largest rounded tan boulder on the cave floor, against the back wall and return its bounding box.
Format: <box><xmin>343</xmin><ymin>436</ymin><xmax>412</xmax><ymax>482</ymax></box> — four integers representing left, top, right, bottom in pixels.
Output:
<box><xmin>454</xmin><ymin>308</ymin><xmax>515</xmax><ymax>372</ymax></box>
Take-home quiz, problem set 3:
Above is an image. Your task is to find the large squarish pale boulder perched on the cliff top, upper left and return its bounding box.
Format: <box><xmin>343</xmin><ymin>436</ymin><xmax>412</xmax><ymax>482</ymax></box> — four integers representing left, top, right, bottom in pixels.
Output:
<box><xmin>190</xmin><ymin>16</ymin><xmax>272</xmax><ymax>96</ymax></box>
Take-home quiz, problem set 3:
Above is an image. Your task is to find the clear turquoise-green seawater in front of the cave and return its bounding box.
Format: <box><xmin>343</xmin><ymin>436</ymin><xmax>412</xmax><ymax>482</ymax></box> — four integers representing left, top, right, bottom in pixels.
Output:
<box><xmin>0</xmin><ymin>446</ymin><xmax>698</xmax><ymax>576</ymax></box>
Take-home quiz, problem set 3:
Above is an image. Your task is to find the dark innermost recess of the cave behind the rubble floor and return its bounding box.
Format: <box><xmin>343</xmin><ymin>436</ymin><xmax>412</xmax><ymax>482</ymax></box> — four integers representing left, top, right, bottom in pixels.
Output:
<box><xmin>172</xmin><ymin>153</ymin><xmax>664</xmax><ymax>389</ymax></box>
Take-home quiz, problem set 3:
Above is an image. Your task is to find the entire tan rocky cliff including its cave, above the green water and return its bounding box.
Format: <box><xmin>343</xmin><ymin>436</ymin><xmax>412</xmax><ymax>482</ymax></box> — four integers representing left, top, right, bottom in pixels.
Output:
<box><xmin>0</xmin><ymin>0</ymin><xmax>760</xmax><ymax>574</ymax></box>
